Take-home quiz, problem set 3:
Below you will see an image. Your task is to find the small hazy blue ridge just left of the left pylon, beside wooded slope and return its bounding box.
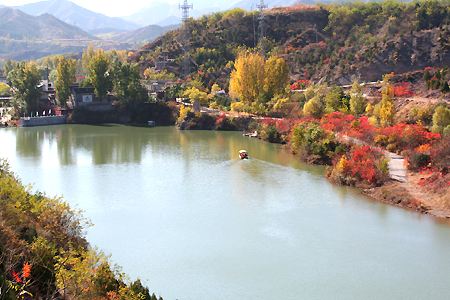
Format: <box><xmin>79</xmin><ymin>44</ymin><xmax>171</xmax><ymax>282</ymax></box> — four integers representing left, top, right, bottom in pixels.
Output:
<box><xmin>105</xmin><ymin>24</ymin><xmax>181</xmax><ymax>45</ymax></box>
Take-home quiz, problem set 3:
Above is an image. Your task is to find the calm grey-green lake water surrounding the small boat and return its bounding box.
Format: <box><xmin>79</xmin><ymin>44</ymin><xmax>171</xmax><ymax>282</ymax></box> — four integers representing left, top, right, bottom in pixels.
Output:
<box><xmin>0</xmin><ymin>124</ymin><xmax>450</xmax><ymax>300</ymax></box>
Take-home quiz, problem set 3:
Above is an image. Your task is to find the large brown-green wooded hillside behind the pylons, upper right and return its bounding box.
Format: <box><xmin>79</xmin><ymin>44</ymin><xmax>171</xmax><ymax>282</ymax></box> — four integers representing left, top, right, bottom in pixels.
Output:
<box><xmin>131</xmin><ymin>0</ymin><xmax>450</xmax><ymax>84</ymax></box>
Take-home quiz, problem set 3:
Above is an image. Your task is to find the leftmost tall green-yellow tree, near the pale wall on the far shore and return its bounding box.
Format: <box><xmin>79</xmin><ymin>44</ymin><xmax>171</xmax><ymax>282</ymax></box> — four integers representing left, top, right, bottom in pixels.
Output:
<box><xmin>8</xmin><ymin>61</ymin><xmax>41</xmax><ymax>113</ymax></box>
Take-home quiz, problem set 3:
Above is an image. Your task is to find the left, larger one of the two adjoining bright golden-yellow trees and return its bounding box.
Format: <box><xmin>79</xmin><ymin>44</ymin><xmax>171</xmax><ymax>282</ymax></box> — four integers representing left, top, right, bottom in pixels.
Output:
<box><xmin>230</xmin><ymin>51</ymin><xmax>265</xmax><ymax>105</ymax></box>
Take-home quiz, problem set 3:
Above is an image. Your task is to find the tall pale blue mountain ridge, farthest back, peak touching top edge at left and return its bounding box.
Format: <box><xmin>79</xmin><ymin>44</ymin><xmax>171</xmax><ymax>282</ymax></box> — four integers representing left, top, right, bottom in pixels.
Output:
<box><xmin>13</xmin><ymin>0</ymin><xmax>139</xmax><ymax>31</ymax></box>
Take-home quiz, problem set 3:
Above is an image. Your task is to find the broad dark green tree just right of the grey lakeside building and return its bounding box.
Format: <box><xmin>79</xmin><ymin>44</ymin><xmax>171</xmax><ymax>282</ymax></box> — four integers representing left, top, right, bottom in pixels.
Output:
<box><xmin>111</xmin><ymin>58</ymin><xmax>148</xmax><ymax>107</ymax></box>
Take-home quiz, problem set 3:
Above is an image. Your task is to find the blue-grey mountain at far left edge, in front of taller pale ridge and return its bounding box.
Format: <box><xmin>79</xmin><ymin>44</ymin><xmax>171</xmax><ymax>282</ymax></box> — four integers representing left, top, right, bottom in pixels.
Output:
<box><xmin>0</xmin><ymin>7</ymin><xmax>97</xmax><ymax>40</ymax></box>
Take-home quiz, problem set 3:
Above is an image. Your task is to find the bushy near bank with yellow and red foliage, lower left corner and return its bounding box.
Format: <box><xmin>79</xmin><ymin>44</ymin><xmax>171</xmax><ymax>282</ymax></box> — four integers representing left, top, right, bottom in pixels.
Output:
<box><xmin>0</xmin><ymin>159</ymin><xmax>162</xmax><ymax>300</ymax></box>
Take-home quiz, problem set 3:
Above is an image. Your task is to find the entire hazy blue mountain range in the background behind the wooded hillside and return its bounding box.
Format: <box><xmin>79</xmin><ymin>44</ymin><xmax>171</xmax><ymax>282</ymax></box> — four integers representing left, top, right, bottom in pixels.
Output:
<box><xmin>0</xmin><ymin>0</ymin><xmax>330</xmax><ymax>59</ymax></box>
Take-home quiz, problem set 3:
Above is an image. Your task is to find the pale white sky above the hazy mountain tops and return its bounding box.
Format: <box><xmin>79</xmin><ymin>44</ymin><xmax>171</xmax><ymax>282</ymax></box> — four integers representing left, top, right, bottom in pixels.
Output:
<box><xmin>0</xmin><ymin>0</ymin><xmax>183</xmax><ymax>17</ymax></box>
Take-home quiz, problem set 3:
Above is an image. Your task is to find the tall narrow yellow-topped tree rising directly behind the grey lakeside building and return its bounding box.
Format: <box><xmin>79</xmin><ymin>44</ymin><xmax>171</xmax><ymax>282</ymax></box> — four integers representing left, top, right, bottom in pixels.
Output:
<box><xmin>88</xmin><ymin>49</ymin><xmax>112</xmax><ymax>98</ymax></box>
